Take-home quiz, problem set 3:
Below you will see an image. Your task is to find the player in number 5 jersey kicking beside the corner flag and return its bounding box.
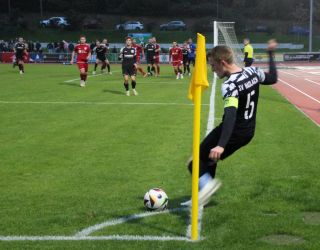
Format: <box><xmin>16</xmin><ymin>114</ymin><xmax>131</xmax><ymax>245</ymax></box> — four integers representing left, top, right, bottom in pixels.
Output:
<box><xmin>181</xmin><ymin>40</ymin><xmax>278</xmax><ymax>206</ymax></box>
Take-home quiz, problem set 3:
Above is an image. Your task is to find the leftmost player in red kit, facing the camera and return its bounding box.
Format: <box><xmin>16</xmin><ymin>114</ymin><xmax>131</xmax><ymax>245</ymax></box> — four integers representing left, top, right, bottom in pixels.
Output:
<box><xmin>70</xmin><ymin>36</ymin><xmax>91</xmax><ymax>87</ymax></box>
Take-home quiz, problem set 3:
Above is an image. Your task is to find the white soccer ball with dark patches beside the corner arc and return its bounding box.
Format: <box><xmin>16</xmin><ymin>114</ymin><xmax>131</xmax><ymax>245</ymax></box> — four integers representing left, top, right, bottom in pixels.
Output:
<box><xmin>144</xmin><ymin>188</ymin><xmax>169</xmax><ymax>211</ymax></box>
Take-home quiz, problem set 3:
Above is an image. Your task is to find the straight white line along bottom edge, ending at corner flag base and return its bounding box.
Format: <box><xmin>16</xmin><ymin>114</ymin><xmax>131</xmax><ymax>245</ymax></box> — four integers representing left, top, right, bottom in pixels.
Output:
<box><xmin>0</xmin><ymin>235</ymin><xmax>190</xmax><ymax>241</ymax></box>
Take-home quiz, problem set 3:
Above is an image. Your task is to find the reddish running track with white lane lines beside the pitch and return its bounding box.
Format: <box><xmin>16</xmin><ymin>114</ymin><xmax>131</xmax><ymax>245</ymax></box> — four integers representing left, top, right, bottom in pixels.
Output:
<box><xmin>273</xmin><ymin>67</ymin><xmax>320</xmax><ymax>126</ymax></box>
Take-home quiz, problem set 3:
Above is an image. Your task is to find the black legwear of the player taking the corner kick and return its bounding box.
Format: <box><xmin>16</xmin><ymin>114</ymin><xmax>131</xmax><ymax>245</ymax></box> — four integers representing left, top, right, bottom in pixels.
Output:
<box><xmin>188</xmin><ymin>123</ymin><xmax>254</xmax><ymax>177</ymax></box>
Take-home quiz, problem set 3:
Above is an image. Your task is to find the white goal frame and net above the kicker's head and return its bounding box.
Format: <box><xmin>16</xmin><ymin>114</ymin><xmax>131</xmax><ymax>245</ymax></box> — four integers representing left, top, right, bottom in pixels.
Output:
<box><xmin>213</xmin><ymin>21</ymin><xmax>243</xmax><ymax>67</ymax></box>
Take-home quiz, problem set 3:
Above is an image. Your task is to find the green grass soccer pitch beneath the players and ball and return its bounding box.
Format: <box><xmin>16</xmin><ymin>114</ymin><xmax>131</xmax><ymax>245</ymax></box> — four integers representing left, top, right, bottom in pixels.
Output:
<box><xmin>0</xmin><ymin>64</ymin><xmax>320</xmax><ymax>249</ymax></box>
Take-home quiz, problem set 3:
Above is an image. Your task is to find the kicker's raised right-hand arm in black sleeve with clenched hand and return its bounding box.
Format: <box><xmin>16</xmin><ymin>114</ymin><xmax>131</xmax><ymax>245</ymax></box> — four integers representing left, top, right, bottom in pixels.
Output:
<box><xmin>261</xmin><ymin>39</ymin><xmax>278</xmax><ymax>85</ymax></box>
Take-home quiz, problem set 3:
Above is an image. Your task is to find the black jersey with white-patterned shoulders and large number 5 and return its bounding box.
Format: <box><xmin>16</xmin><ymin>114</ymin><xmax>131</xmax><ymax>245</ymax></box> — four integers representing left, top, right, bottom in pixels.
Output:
<box><xmin>221</xmin><ymin>67</ymin><xmax>265</xmax><ymax>136</ymax></box>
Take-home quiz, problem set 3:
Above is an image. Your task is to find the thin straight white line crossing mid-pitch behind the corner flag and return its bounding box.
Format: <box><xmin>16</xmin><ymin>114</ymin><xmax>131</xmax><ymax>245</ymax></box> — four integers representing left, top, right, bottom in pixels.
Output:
<box><xmin>0</xmin><ymin>101</ymin><xmax>210</xmax><ymax>106</ymax></box>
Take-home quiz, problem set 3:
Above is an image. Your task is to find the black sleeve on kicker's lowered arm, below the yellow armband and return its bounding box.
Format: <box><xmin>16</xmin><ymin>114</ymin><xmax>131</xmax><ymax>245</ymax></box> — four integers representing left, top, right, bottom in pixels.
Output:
<box><xmin>218</xmin><ymin>107</ymin><xmax>237</xmax><ymax>148</ymax></box>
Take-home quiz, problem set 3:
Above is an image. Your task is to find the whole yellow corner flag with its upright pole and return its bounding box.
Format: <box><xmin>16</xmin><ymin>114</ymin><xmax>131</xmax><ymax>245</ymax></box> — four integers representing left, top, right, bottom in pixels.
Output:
<box><xmin>188</xmin><ymin>33</ymin><xmax>209</xmax><ymax>240</ymax></box>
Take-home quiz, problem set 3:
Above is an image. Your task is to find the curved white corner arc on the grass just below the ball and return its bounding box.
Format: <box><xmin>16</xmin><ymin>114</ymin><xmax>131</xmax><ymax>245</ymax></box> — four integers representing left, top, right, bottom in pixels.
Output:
<box><xmin>74</xmin><ymin>208</ymin><xmax>187</xmax><ymax>237</ymax></box>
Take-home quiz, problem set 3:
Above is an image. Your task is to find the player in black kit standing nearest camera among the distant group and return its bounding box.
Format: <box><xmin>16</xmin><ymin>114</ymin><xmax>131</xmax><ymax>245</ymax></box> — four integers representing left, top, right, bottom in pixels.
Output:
<box><xmin>120</xmin><ymin>37</ymin><xmax>138</xmax><ymax>96</ymax></box>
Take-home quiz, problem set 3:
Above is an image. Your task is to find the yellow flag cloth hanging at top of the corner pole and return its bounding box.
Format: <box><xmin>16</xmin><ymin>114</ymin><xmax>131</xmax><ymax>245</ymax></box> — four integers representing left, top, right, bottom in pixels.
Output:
<box><xmin>188</xmin><ymin>33</ymin><xmax>209</xmax><ymax>102</ymax></box>
